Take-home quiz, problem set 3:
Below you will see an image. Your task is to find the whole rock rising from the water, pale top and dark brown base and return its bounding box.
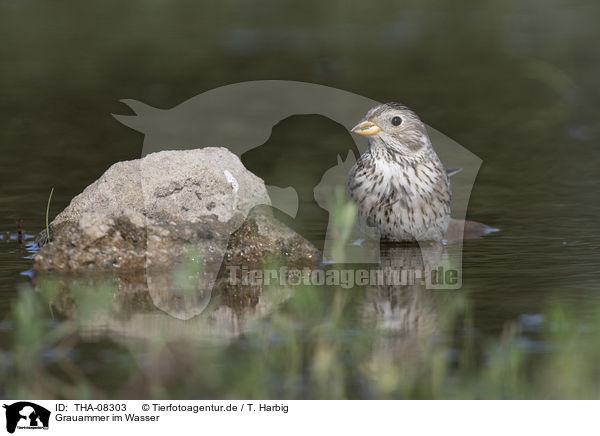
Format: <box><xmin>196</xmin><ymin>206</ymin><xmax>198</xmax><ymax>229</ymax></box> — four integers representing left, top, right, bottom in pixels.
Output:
<box><xmin>35</xmin><ymin>148</ymin><xmax>318</xmax><ymax>276</ymax></box>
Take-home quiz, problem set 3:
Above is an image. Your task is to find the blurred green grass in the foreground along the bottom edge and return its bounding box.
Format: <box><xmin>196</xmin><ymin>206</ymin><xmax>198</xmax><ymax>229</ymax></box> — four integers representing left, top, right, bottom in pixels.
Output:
<box><xmin>0</xmin><ymin>281</ymin><xmax>600</xmax><ymax>399</ymax></box>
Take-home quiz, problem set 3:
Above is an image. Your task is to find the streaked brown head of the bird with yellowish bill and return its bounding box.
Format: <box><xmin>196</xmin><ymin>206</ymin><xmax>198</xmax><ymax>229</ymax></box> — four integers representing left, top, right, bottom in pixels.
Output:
<box><xmin>352</xmin><ymin>102</ymin><xmax>431</xmax><ymax>156</ymax></box>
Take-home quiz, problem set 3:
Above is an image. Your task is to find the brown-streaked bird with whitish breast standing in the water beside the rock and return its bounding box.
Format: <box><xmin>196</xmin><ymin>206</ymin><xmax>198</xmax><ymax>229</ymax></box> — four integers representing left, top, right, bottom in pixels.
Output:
<box><xmin>348</xmin><ymin>102</ymin><xmax>450</xmax><ymax>242</ymax></box>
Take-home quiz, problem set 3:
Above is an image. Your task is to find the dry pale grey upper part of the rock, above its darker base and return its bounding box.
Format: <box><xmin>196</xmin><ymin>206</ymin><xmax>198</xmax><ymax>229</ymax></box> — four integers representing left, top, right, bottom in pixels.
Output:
<box><xmin>52</xmin><ymin>147</ymin><xmax>271</xmax><ymax>227</ymax></box>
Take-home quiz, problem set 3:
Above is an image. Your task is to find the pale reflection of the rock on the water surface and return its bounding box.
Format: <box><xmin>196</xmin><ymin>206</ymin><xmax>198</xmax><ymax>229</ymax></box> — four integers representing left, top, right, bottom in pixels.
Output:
<box><xmin>36</xmin><ymin>271</ymin><xmax>291</xmax><ymax>343</ymax></box>
